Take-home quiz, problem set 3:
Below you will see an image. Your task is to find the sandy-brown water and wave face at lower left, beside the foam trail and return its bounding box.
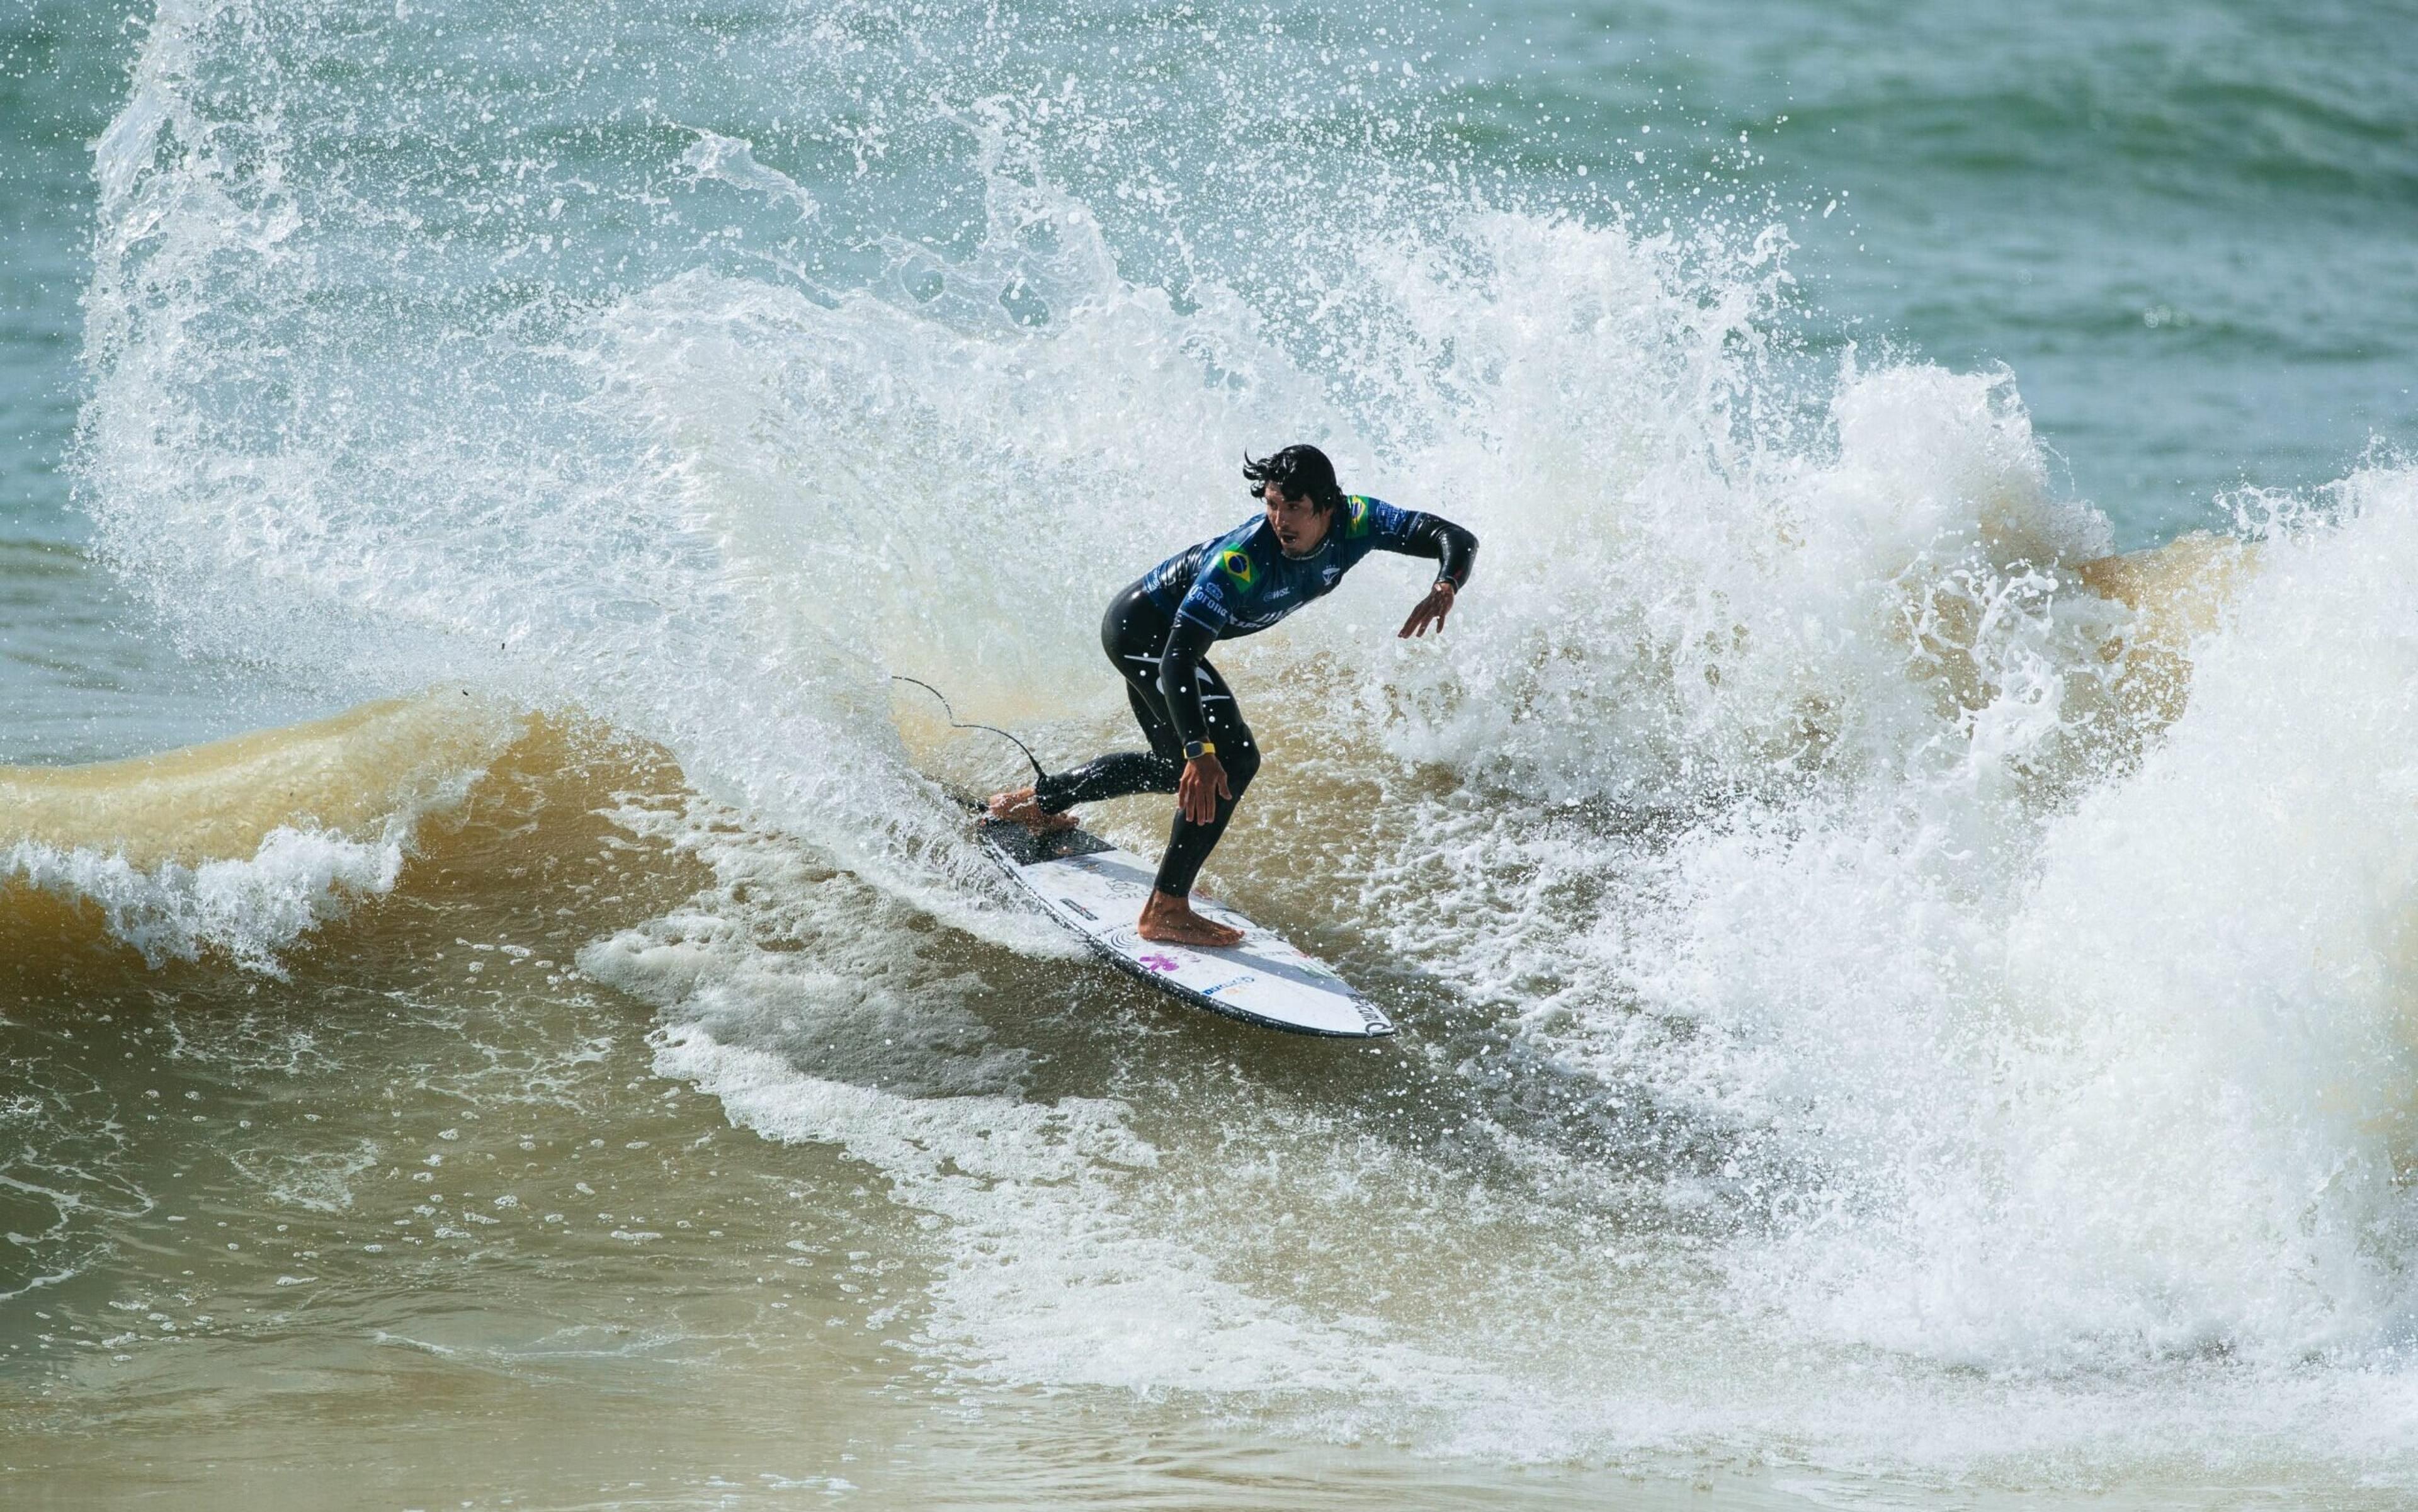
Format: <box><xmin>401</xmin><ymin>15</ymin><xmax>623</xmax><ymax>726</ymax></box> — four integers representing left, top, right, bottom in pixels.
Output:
<box><xmin>0</xmin><ymin>719</ymin><xmax>1808</xmax><ymax>1509</ymax></box>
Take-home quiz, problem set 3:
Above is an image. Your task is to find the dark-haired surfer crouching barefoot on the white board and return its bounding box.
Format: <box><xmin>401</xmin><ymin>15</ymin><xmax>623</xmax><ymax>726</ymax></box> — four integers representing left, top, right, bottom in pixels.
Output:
<box><xmin>989</xmin><ymin>445</ymin><xmax>1477</xmax><ymax>946</ymax></box>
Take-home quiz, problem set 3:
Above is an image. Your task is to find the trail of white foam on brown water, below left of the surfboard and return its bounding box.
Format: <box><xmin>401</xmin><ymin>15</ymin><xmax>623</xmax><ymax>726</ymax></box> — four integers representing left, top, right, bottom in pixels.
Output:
<box><xmin>581</xmin><ymin>805</ymin><xmax>1480</xmax><ymax>1396</ymax></box>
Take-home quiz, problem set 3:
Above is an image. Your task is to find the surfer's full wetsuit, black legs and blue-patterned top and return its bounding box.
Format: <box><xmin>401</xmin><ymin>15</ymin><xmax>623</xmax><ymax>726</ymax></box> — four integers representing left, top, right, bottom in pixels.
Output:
<box><xmin>1035</xmin><ymin>496</ymin><xmax>1477</xmax><ymax>897</ymax></box>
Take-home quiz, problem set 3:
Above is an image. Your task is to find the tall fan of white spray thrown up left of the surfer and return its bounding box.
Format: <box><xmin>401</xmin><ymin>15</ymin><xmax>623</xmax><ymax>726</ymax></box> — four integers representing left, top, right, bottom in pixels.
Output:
<box><xmin>77</xmin><ymin>12</ymin><xmax>1306</xmax><ymax>934</ymax></box>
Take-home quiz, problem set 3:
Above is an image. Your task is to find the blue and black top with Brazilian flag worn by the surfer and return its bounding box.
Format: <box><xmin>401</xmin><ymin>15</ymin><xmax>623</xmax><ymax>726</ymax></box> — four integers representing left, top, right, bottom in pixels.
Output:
<box><xmin>1139</xmin><ymin>494</ymin><xmax>1477</xmax><ymax>741</ymax></box>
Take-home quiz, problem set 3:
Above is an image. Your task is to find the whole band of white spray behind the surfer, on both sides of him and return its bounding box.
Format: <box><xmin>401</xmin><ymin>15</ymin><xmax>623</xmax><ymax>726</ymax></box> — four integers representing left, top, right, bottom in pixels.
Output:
<box><xmin>80</xmin><ymin>0</ymin><xmax>2104</xmax><ymax>987</ymax></box>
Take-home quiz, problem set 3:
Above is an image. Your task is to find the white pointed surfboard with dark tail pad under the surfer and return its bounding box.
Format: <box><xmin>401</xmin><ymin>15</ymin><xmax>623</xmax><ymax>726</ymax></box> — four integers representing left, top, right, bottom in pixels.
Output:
<box><xmin>975</xmin><ymin>816</ymin><xmax>1393</xmax><ymax>1040</ymax></box>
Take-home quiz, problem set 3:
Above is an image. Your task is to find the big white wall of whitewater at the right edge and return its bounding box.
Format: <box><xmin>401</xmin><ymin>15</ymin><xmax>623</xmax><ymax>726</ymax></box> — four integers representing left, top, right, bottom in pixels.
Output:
<box><xmin>1569</xmin><ymin>467</ymin><xmax>2418</xmax><ymax>1369</ymax></box>
